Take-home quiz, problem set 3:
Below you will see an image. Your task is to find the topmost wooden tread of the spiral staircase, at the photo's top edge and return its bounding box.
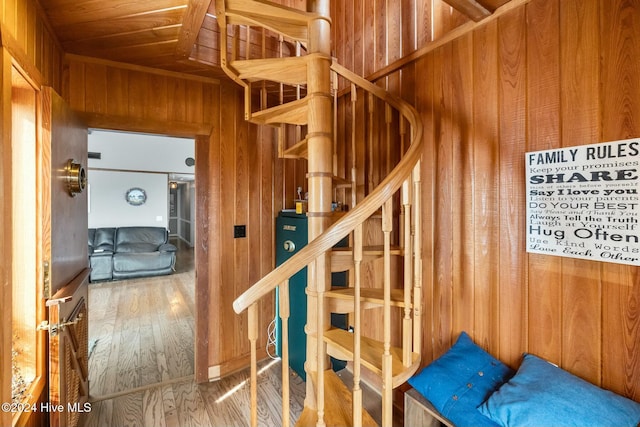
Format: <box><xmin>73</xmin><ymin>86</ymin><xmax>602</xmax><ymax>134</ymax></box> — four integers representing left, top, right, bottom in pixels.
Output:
<box><xmin>225</xmin><ymin>0</ymin><xmax>318</xmax><ymax>41</ymax></box>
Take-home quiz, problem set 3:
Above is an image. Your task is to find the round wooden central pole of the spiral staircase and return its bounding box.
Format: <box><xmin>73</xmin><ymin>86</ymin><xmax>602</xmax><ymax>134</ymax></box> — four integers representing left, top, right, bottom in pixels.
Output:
<box><xmin>305</xmin><ymin>0</ymin><xmax>333</xmax><ymax>414</ymax></box>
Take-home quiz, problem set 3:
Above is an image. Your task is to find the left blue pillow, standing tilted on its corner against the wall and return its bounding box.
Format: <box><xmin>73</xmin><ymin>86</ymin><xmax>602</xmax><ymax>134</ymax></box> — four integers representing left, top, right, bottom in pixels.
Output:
<box><xmin>409</xmin><ymin>332</ymin><xmax>513</xmax><ymax>427</ymax></box>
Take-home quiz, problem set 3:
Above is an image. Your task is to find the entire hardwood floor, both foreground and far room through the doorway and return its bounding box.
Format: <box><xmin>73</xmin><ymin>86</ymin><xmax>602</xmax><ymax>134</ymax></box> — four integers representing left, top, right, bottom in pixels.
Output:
<box><xmin>81</xmin><ymin>242</ymin><xmax>395</xmax><ymax>427</ymax></box>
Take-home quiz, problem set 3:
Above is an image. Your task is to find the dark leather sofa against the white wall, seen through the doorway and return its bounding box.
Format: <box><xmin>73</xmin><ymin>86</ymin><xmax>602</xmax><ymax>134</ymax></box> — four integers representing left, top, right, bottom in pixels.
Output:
<box><xmin>88</xmin><ymin>226</ymin><xmax>177</xmax><ymax>282</ymax></box>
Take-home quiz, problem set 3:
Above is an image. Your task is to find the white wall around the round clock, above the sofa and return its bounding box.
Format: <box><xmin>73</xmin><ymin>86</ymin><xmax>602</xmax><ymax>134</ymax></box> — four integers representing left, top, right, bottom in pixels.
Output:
<box><xmin>87</xmin><ymin>170</ymin><xmax>169</xmax><ymax>228</ymax></box>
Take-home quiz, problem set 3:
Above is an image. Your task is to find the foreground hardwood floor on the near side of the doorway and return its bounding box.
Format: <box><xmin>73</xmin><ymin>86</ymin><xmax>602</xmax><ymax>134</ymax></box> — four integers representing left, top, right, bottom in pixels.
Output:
<box><xmin>84</xmin><ymin>361</ymin><xmax>305</xmax><ymax>427</ymax></box>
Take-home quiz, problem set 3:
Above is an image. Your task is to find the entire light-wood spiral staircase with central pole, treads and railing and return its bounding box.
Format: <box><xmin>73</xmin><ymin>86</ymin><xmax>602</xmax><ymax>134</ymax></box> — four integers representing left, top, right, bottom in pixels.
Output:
<box><xmin>216</xmin><ymin>0</ymin><xmax>422</xmax><ymax>426</ymax></box>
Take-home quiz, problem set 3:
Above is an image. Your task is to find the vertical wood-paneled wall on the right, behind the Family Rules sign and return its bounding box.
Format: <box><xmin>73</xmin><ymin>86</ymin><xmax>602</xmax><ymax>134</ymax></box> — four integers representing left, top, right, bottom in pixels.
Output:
<box><xmin>332</xmin><ymin>0</ymin><xmax>640</xmax><ymax>401</ymax></box>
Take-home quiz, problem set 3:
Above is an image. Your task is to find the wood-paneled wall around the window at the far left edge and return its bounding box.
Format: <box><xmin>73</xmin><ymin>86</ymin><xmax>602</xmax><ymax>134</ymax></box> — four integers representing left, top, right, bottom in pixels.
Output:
<box><xmin>0</xmin><ymin>0</ymin><xmax>62</xmax><ymax>426</ymax></box>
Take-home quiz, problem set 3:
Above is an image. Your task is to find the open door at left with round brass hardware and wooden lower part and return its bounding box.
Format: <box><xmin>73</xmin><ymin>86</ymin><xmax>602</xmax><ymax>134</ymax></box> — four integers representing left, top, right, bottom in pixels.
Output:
<box><xmin>42</xmin><ymin>88</ymin><xmax>91</xmax><ymax>427</ymax></box>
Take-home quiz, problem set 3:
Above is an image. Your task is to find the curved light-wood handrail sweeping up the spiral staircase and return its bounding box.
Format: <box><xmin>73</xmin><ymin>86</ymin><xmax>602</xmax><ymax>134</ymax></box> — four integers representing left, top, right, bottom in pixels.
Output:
<box><xmin>233</xmin><ymin>61</ymin><xmax>422</xmax><ymax>314</ymax></box>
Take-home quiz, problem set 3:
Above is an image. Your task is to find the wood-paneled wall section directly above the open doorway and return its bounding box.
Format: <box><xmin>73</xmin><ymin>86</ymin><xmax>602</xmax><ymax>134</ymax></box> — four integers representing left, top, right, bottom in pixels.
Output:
<box><xmin>63</xmin><ymin>55</ymin><xmax>220</xmax><ymax>137</ymax></box>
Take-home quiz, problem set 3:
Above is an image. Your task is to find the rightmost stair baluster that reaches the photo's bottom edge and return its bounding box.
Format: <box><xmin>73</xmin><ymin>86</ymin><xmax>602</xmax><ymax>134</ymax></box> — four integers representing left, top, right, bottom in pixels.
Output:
<box><xmin>382</xmin><ymin>198</ymin><xmax>393</xmax><ymax>426</ymax></box>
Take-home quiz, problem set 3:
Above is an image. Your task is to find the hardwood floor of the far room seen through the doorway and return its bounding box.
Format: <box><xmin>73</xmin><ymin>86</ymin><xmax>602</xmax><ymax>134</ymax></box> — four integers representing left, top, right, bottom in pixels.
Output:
<box><xmin>89</xmin><ymin>271</ymin><xmax>195</xmax><ymax>398</ymax></box>
